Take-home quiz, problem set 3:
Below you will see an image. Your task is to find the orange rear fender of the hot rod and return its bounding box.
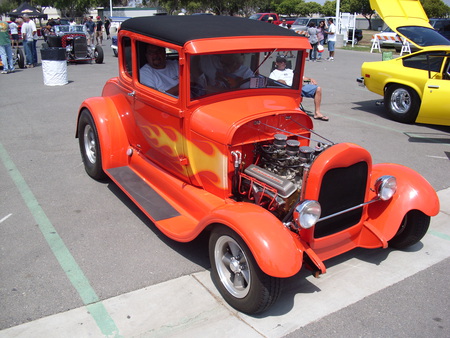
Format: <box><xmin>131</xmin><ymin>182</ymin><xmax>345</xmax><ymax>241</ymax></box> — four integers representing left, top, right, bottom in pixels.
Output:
<box><xmin>75</xmin><ymin>97</ymin><xmax>130</xmax><ymax>170</ymax></box>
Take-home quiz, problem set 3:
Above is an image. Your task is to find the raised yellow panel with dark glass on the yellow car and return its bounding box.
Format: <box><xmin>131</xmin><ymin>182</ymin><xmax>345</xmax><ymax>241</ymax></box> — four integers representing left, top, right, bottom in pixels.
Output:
<box><xmin>370</xmin><ymin>0</ymin><xmax>450</xmax><ymax>48</ymax></box>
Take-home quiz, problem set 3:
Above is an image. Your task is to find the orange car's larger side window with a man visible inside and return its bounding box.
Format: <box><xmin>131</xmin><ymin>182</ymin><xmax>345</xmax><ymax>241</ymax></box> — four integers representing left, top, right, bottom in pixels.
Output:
<box><xmin>136</xmin><ymin>42</ymin><xmax>179</xmax><ymax>97</ymax></box>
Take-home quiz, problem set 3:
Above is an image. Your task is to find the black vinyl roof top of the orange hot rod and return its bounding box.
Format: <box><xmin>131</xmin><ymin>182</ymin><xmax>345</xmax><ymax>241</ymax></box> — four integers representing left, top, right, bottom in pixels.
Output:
<box><xmin>120</xmin><ymin>15</ymin><xmax>300</xmax><ymax>46</ymax></box>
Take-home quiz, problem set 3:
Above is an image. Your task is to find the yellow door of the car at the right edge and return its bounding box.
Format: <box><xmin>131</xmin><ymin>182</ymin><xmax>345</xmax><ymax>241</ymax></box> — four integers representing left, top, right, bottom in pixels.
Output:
<box><xmin>416</xmin><ymin>58</ymin><xmax>450</xmax><ymax>125</ymax></box>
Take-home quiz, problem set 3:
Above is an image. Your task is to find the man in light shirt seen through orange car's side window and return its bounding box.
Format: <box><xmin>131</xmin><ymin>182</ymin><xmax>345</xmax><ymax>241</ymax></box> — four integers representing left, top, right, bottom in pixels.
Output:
<box><xmin>139</xmin><ymin>44</ymin><xmax>179</xmax><ymax>96</ymax></box>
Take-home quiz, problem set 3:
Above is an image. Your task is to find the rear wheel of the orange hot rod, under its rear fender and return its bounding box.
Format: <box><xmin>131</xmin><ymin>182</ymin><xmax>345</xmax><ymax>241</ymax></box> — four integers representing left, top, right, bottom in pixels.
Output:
<box><xmin>78</xmin><ymin>109</ymin><xmax>106</xmax><ymax>180</ymax></box>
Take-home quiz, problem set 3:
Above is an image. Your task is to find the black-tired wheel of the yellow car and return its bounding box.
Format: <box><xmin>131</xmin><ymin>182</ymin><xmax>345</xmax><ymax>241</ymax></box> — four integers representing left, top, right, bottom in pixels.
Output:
<box><xmin>384</xmin><ymin>84</ymin><xmax>421</xmax><ymax>123</ymax></box>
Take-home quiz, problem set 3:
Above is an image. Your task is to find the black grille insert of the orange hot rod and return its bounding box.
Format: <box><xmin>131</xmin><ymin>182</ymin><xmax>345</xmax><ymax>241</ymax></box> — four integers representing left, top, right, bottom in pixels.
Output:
<box><xmin>314</xmin><ymin>161</ymin><xmax>368</xmax><ymax>238</ymax></box>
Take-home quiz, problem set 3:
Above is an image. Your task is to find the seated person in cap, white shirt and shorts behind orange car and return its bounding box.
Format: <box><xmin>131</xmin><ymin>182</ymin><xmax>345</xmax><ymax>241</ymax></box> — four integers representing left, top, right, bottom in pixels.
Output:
<box><xmin>269</xmin><ymin>56</ymin><xmax>328</xmax><ymax>121</ymax></box>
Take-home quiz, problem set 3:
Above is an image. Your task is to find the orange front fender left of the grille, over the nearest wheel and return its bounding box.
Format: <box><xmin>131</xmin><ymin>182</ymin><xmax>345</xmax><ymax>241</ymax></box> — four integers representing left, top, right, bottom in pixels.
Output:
<box><xmin>200</xmin><ymin>202</ymin><xmax>305</xmax><ymax>278</ymax></box>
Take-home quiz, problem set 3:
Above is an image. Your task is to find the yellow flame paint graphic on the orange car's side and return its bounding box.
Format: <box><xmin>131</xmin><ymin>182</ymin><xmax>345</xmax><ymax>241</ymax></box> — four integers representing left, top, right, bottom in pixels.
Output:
<box><xmin>141</xmin><ymin>124</ymin><xmax>228</xmax><ymax>189</ymax></box>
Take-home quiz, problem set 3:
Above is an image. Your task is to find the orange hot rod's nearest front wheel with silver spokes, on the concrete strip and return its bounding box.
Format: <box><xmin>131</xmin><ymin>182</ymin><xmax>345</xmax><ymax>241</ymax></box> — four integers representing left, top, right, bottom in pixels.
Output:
<box><xmin>209</xmin><ymin>226</ymin><xmax>282</xmax><ymax>314</ymax></box>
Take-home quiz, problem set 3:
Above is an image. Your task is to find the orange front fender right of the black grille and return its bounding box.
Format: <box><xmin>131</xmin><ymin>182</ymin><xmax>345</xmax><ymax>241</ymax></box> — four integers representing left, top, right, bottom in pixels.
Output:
<box><xmin>367</xmin><ymin>163</ymin><xmax>439</xmax><ymax>241</ymax></box>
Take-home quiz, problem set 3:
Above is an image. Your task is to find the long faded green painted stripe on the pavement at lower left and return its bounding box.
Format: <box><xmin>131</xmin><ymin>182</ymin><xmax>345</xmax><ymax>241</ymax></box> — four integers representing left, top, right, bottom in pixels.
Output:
<box><xmin>0</xmin><ymin>143</ymin><xmax>121</xmax><ymax>337</ymax></box>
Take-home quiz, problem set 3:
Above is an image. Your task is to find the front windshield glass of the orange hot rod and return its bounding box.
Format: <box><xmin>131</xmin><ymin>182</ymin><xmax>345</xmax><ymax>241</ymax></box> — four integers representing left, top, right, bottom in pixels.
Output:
<box><xmin>190</xmin><ymin>50</ymin><xmax>302</xmax><ymax>98</ymax></box>
